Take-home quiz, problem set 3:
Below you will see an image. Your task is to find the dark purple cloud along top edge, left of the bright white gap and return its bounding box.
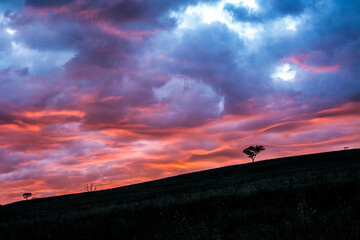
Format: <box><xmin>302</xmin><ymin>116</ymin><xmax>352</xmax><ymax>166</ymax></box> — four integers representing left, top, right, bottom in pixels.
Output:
<box><xmin>26</xmin><ymin>0</ymin><xmax>218</xmax><ymax>28</ymax></box>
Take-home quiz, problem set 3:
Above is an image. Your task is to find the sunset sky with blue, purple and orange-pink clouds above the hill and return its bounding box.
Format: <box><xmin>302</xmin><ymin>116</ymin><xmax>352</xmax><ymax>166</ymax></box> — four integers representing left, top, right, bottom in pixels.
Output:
<box><xmin>0</xmin><ymin>0</ymin><xmax>360</xmax><ymax>204</ymax></box>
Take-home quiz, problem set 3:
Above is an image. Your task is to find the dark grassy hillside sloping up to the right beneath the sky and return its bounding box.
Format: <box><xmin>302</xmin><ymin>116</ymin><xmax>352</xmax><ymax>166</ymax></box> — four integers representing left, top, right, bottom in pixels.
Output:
<box><xmin>0</xmin><ymin>149</ymin><xmax>360</xmax><ymax>239</ymax></box>
